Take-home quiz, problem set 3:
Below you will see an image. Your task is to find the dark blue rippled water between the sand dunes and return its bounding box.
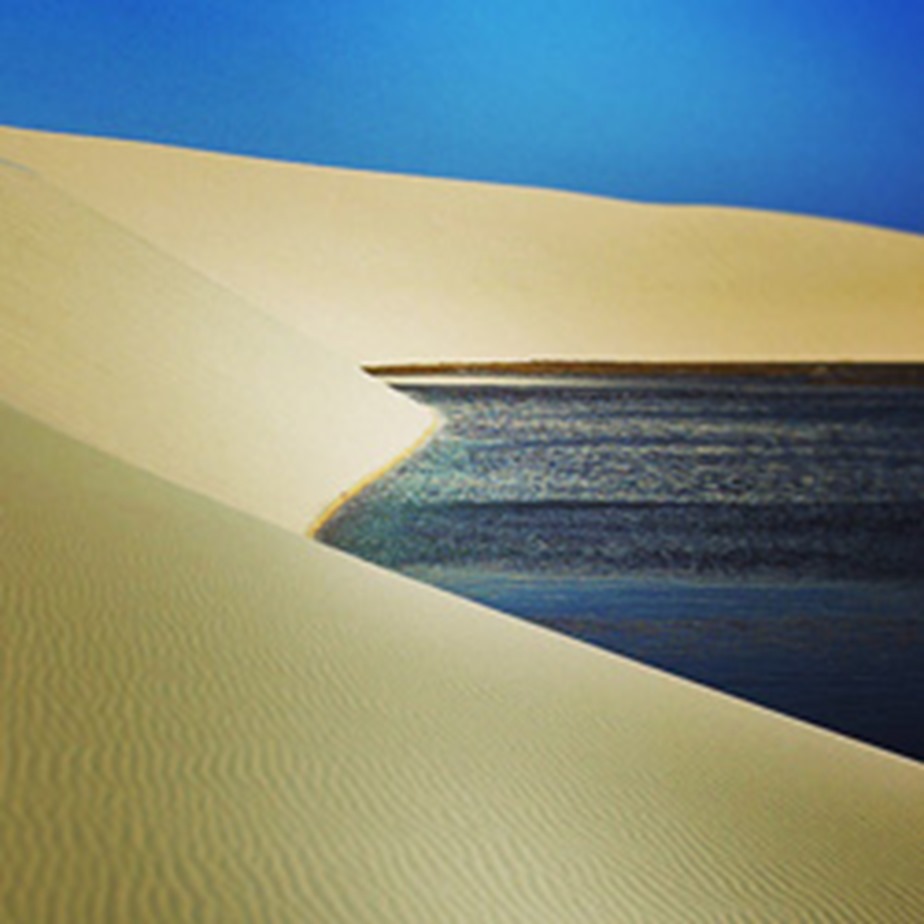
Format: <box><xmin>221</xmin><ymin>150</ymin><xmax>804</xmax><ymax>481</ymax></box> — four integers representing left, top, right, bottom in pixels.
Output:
<box><xmin>321</xmin><ymin>378</ymin><xmax>924</xmax><ymax>760</ymax></box>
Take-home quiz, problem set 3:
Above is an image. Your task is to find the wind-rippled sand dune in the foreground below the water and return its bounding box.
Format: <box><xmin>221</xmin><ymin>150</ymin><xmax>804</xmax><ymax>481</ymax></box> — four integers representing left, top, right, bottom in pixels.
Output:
<box><xmin>0</xmin><ymin>408</ymin><xmax>924</xmax><ymax>924</ymax></box>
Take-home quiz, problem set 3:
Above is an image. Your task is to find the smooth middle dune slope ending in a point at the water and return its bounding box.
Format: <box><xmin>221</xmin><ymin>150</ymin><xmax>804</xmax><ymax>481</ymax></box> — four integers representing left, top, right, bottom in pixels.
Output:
<box><xmin>0</xmin><ymin>166</ymin><xmax>429</xmax><ymax>529</ymax></box>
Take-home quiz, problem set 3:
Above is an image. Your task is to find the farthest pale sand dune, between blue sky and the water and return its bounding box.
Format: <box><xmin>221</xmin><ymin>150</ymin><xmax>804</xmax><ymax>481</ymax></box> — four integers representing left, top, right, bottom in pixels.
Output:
<box><xmin>0</xmin><ymin>129</ymin><xmax>924</xmax><ymax>361</ymax></box>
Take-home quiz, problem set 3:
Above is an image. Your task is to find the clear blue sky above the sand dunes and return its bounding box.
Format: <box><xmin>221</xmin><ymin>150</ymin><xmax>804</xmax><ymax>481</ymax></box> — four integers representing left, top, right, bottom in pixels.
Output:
<box><xmin>0</xmin><ymin>0</ymin><xmax>924</xmax><ymax>233</ymax></box>
